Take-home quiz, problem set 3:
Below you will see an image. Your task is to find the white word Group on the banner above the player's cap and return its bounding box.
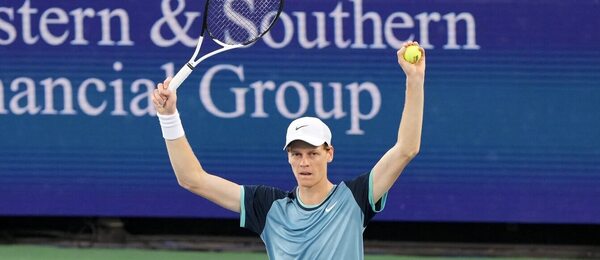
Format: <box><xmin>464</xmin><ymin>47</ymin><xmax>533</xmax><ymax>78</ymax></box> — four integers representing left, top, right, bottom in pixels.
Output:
<box><xmin>200</xmin><ymin>64</ymin><xmax>381</xmax><ymax>135</ymax></box>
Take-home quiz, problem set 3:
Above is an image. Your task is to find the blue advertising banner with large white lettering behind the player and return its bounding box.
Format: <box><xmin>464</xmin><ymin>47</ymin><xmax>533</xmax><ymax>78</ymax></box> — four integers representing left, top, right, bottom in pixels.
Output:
<box><xmin>0</xmin><ymin>0</ymin><xmax>600</xmax><ymax>224</ymax></box>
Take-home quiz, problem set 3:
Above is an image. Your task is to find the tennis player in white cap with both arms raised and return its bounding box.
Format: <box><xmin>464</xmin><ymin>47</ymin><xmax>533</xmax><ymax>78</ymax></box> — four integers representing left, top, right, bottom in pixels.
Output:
<box><xmin>152</xmin><ymin>42</ymin><xmax>425</xmax><ymax>259</ymax></box>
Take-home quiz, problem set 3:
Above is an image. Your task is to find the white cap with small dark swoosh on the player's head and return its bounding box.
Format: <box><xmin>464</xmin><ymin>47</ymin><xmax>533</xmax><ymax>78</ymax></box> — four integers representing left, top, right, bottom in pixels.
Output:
<box><xmin>283</xmin><ymin>117</ymin><xmax>331</xmax><ymax>150</ymax></box>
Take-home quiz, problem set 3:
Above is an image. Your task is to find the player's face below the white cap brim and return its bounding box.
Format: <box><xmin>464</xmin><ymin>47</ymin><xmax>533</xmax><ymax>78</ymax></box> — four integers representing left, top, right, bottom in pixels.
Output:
<box><xmin>287</xmin><ymin>141</ymin><xmax>333</xmax><ymax>187</ymax></box>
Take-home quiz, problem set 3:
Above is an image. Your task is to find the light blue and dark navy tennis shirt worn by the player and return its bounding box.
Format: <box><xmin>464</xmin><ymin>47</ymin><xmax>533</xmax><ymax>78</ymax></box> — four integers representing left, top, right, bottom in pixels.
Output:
<box><xmin>240</xmin><ymin>173</ymin><xmax>387</xmax><ymax>260</ymax></box>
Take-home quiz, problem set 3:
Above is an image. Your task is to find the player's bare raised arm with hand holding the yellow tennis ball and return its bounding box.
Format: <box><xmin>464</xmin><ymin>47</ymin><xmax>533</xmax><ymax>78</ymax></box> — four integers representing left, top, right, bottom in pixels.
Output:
<box><xmin>372</xmin><ymin>42</ymin><xmax>426</xmax><ymax>201</ymax></box>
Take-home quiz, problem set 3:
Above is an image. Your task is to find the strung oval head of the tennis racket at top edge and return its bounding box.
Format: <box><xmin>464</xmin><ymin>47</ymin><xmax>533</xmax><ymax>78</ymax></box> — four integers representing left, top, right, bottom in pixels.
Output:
<box><xmin>203</xmin><ymin>0</ymin><xmax>283</xmax><ymax>46</ymax></box>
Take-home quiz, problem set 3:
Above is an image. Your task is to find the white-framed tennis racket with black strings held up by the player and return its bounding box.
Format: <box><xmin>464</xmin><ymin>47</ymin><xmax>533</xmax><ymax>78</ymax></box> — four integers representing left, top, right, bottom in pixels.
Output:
<box><xmin>169</xmin><ymin>0</ymin><xmax>283</xmax><ymax>91</ymax></box>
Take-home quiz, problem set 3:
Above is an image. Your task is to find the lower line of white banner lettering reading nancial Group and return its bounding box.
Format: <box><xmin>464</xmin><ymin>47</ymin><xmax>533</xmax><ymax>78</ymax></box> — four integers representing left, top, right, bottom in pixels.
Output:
<box><xmin>0</xmin><ymin>61</ymin><xmax>381</xmax><ymax>135</ymax></box>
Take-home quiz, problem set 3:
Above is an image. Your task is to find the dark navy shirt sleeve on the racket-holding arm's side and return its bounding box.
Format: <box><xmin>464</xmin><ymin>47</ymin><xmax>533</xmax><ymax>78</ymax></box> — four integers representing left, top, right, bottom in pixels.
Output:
<box><xmin>240</xmin><ymin>185</ymin><xmax>287</xmax><ymax>235</ymax></box>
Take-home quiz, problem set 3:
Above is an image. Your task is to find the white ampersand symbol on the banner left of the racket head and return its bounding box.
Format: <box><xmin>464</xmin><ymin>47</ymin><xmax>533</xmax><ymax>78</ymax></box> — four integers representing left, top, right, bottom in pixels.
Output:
<box><xmin>150</xmin><ymin>0</ymin><xmax>200</xmax><ymax>47</ymax></box>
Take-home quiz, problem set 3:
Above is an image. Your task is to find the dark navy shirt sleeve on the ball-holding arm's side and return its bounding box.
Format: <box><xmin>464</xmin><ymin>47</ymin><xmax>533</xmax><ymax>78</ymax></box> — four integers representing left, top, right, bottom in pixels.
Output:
<box><xmin>344</xmin><ymin>172</ymin><xmax>387</xmax><ymax>227</ymax></box>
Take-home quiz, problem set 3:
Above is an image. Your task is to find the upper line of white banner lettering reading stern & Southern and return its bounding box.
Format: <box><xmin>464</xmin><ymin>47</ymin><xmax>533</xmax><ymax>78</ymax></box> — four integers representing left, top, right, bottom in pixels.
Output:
<box><xmin>0</xmin><ymin>0</ymin><xmax>481</xmax><ymax>50</ymax></box>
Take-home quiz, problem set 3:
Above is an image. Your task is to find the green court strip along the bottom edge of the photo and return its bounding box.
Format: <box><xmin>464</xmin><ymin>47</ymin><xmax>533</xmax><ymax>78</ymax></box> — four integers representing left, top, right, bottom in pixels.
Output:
<box><xmin>0</xmin><ymin>245</ymin><xmax>568</xmax><ymax>260</ymax></box>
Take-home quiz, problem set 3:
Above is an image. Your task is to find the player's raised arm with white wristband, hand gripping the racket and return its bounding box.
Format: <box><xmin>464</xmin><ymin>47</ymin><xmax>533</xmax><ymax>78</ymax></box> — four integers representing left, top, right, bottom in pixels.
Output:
<box><xmin>152</xmin><ymin>78</ymin><xmax>241</xmax><ymax>212</ymax></box>
